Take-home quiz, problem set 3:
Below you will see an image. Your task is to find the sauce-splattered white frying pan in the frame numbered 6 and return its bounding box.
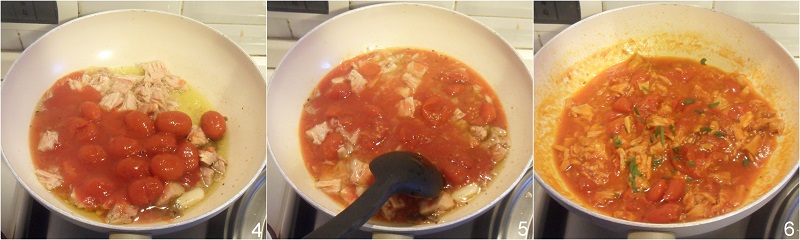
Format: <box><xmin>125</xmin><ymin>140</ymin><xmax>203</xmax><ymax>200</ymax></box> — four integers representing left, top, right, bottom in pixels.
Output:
<box><xmin>534</xmin><ymin>4</ymin><xmax>800</xmax><ymax>237</ymax></box>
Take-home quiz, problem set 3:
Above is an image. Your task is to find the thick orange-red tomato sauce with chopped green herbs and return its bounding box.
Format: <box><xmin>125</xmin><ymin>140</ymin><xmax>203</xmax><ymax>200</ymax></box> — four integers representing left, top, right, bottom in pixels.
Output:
<box><xmin>554</xmin><ymin>55</ymin><xmax>783</xmax><ymax>223</ymax></box>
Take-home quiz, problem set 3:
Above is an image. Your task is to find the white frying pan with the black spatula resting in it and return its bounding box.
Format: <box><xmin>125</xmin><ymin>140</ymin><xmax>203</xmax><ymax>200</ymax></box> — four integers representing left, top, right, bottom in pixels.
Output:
<box><xmin>267</xmin><ymin>4</ymin><xmax>533</xmax><ymax>234</ymax></box>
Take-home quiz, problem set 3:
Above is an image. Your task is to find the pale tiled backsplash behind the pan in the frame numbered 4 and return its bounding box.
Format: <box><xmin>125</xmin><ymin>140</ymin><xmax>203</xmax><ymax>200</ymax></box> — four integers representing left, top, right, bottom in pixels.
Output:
<box><xmin>0</xmin><ymin>1</ymin><xmax>267</xmax><ymax>56</ymax></box>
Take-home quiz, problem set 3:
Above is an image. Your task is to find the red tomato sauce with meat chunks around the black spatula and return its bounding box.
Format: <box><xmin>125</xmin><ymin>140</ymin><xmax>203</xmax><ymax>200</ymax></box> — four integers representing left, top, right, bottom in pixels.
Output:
<box><xmin>300</xmin><ymin>49</ymin><xmax>507</xmax><ymax>222</ymax></box>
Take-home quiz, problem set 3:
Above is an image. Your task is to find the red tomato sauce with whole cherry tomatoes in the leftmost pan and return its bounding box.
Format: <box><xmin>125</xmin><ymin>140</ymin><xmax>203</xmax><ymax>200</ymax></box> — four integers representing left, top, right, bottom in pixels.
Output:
<box><xmin>29</xmin><ymin>71</ymin><xmax>225</xmax><ymax>223</ymax></box>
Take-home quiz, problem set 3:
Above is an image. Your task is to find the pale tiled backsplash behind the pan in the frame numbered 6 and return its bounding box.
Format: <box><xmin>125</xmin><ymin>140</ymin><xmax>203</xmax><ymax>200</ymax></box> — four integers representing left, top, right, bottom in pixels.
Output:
<box><xmin>533</xmin><ymin>1</ymin><xmax>800</xmax><ymax>57</ymax></box>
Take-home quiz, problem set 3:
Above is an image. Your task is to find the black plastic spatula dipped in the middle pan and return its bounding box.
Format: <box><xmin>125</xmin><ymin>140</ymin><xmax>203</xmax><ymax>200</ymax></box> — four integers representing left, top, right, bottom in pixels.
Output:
<box><xmin>305</xmin><ymin>152</ymin><xmax>444</xmax><ymax>238</ymax></box>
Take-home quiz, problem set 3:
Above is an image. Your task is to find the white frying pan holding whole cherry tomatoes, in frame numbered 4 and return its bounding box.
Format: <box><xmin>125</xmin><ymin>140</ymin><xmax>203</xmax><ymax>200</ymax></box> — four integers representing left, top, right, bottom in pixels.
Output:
<box><xmin>0</xmin><ymin>10</ymin><xmax>266</xmax><ymax>234</ymax></box>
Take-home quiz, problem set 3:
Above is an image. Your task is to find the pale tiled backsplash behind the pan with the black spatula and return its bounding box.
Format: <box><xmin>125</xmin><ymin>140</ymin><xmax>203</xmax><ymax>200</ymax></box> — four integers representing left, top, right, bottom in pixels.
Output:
<box><xmin>267</xmin><ymin>1</ymin><xmax>533</xmax><ymax>49</ymax></box>
